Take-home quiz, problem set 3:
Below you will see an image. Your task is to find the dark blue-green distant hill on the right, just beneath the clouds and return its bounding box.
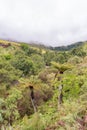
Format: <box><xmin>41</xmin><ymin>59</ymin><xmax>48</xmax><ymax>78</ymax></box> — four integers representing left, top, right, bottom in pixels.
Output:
<box><xmin>50</xmin><ymin>42</ymin><xmax>85</xmax><ymax>51</ymax></box>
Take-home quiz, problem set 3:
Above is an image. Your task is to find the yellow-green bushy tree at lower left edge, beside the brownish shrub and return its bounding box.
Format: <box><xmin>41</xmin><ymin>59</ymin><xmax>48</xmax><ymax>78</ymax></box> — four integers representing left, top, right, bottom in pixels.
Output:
<box><xmin>0</xmin><ymin>88</ymin><xmax>22</xmax><ymax>125</ymax></box>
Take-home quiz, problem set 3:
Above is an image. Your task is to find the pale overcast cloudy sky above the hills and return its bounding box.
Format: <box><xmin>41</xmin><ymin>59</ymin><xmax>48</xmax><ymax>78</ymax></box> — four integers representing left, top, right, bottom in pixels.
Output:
<box><xmin>0</xmin><ymin>0</ymin><xmax>87</xmax><ymax>46</ymax></box>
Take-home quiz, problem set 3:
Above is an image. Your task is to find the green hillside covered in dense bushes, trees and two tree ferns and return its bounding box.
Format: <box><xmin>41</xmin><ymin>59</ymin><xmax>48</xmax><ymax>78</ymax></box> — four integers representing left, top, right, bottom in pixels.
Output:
<box><xmin>0</xmin><ymin>40</ymin><xmax>87</xmax><ymax>130</ymax></box>
